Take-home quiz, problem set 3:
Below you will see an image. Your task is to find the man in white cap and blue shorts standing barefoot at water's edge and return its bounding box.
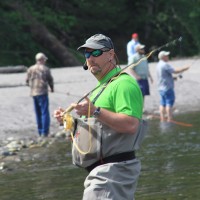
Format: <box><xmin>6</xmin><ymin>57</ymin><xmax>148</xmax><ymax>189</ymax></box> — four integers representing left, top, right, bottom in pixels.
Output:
<box><xmin>157</xmin><ymin>51</ymin><xmax>189</xmax><ymax>122</ymax></box>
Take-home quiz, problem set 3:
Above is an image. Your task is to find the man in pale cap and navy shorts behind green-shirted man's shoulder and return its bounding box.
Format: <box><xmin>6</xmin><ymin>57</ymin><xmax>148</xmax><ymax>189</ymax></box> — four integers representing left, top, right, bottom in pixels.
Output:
<box><xmin>130</xmin><ymin>44</ymin><xmax>153</xmax><ymax>110</ymax></box>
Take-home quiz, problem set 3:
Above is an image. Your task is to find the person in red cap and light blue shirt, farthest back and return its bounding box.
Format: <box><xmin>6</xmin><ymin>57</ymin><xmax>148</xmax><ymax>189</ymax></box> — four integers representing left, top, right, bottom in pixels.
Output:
<box><xmin>127</xmin><ymin>33</ymin><xmax>140</xmax><ymax>65</ymax></box>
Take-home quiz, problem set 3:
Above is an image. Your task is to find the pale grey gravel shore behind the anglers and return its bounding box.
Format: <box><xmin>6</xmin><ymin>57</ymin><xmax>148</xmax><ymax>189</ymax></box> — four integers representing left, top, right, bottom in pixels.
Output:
<box><xmin>0</xmin><ymin>58</ymin><xmax>200</xmax><ymax>164</ymax></box>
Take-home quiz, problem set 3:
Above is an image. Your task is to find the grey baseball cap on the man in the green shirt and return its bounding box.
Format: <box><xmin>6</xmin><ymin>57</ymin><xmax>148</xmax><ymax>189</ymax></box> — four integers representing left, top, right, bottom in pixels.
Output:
<box><xmin>77</xmin><ymin>34</ymin><xmax>114</xmax><ymax>50</ymax></box>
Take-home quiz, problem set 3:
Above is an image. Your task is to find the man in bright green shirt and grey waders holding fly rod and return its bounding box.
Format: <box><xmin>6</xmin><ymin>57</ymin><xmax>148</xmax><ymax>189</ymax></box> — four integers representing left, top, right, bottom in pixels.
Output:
<box><xmin>54</xmin><ymin>34</ymin><xmax>147</xmax><ymax>200</ymax></box>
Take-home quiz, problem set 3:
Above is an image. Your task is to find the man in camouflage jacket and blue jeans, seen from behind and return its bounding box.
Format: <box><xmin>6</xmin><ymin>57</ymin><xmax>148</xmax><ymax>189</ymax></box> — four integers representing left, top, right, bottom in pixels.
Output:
<box><xmin>26</xmin><ymin>53</ymin><xmax>54</xmax><ymax>137</ymax></box>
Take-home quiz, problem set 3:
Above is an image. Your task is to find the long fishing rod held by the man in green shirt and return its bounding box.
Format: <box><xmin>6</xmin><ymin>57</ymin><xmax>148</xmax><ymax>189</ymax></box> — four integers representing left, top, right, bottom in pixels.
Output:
<box><xmin>62</xmin><ymin>37</ymin><xmax>182</xmax><ymax>116</ymax></box>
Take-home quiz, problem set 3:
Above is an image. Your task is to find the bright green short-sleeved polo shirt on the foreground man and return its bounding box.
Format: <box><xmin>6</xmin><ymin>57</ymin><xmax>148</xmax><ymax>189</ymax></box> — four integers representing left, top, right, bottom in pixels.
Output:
<box><xmin>90</xmin><ymin>68</ymin><xmax>143</xmax><ymax>119</ymax></box>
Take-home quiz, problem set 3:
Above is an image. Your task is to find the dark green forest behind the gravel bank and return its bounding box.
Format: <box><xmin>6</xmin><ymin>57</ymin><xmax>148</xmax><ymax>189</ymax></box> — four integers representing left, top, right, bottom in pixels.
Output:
<box><xmin>0</xmin><ymin>0</ymin><xmax>200</xmax><ymax>68</ymax></box>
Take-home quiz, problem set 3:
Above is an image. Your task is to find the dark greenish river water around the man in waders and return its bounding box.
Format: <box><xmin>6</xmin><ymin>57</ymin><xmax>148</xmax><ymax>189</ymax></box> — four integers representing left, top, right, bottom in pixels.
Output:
<box><xmin>0</xmin><ymin>112</ymin><xmax>200</xmax><ymax>200</ymax></box>
